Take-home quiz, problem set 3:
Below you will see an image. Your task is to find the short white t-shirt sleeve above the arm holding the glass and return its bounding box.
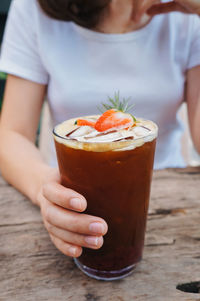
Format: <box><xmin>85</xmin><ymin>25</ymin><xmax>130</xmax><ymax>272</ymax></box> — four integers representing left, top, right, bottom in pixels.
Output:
<box><xmin>0</xmin><ymin>0</ymin><xmax>48</xmax><ymax>84</ymax></box>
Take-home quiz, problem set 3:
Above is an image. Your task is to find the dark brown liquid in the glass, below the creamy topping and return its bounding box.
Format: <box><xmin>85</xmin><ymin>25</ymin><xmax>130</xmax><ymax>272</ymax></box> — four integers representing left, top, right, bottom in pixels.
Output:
<box><xmin>55</xmin><ymin>139</ymin><xmax>156</xmax><ymax>277</ymax></box>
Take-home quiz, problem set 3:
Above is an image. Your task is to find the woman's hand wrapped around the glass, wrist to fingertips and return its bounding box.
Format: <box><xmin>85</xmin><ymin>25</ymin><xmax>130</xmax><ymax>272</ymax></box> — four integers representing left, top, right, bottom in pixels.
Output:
<box><xmin>37</xmin><ymin>169</ymin><xmax>108</xmax><ymax>257</ymax></box>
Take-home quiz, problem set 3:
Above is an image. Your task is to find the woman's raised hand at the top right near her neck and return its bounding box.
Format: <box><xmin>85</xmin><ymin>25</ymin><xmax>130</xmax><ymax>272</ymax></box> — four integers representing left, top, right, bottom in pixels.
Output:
<box><xmin>133</xmin><ymin>0</ymin><xmax>200</xmax><ymax>22</ymax></box>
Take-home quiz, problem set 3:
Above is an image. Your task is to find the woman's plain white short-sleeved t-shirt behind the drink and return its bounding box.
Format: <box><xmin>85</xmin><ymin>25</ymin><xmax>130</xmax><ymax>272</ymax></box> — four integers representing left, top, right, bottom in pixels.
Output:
<box><xmin>0</xmin><ymin>0</ymin><xmax>200</xmax><ymax>169</ymax></box>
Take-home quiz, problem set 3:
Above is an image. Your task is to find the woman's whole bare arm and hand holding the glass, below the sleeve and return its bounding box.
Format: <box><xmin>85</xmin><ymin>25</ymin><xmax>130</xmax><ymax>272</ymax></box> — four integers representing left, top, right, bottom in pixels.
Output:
<box><xmin>0</xmin><ymin>75</ymin><xmax>107</xmax><ymax>257</ymax></box>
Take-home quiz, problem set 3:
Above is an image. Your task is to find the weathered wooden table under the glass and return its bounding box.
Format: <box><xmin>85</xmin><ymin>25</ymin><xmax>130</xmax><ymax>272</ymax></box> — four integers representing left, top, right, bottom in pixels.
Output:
<box><xmin>0</xmin><ymin>167</ymin><xmax>200</xmax><ymax>301</ymax></box>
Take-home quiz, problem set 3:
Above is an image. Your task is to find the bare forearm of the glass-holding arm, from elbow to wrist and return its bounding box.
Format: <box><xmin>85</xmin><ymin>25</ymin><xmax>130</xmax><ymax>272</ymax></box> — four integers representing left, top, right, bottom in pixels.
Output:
<box><xmin>0</xmin><ymin>130</ymin><xmax>55</xmax><ymax>205</ymax></box>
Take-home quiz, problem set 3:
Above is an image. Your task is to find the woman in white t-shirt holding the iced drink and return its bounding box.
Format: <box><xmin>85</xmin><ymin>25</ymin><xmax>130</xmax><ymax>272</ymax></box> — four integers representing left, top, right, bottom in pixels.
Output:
<box><xmin>0</xmin><ymin>0</ymin><xmax>200</xmax><ymax>257</ymax></box>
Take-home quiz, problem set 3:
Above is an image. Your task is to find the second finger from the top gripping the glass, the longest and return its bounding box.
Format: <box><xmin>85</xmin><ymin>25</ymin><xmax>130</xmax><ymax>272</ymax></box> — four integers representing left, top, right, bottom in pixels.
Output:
<box><xmin>42</xmin><ymin>202</ymin><xmax>108</xmax><ymax>236</ymax></box>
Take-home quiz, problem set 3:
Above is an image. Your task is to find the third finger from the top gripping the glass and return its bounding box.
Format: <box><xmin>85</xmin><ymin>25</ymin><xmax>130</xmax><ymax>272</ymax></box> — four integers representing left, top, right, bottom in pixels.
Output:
<box><xmin>45</xmin><ymin>222</ymin><xmax>103</xmax><ymax>249</ymax></box>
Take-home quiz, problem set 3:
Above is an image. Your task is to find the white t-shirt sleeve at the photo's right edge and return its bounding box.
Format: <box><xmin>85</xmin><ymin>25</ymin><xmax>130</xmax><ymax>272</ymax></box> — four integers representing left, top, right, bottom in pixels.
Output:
<box><xmin>187</xmin><ymin>16</ymin><xmax>200</xmax><ymax>69</ymax></box>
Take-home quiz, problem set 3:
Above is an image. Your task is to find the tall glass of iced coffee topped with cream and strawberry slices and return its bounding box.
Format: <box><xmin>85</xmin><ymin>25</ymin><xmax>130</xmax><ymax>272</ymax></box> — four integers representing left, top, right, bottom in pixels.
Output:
<box><xmin>54</xmin><ymin>95</ymin><xmax>157</xmax><ymax>280</ymax></box>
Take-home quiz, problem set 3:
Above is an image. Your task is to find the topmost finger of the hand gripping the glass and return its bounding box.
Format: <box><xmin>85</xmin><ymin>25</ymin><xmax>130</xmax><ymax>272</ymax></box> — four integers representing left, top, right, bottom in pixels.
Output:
<box><xmin>43</xmin><ymin>182</ymin><xmax>87</xmax><ymax>212</ymax></box>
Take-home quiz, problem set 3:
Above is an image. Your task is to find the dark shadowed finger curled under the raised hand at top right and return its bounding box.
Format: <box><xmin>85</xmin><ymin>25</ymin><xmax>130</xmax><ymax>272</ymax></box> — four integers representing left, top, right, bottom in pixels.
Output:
<box><xmin>147</xmin><ymin>2</ymin><xmax>188</xmax><ymax>15</ymax></box>
